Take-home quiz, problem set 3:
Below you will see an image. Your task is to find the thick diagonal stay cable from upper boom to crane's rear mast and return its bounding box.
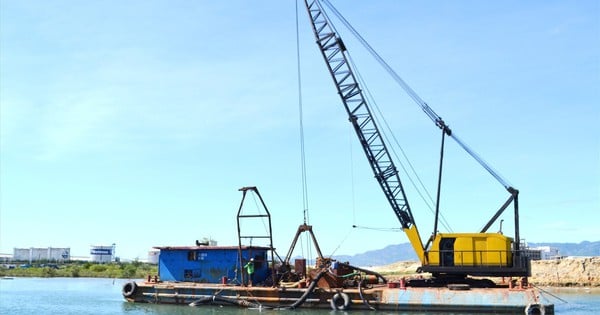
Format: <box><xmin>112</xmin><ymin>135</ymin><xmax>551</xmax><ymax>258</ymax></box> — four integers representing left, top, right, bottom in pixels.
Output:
<box><xmin>322</xmin><ymin>0</ymin><xmax>512</xmax><ymax>191</ymax></box>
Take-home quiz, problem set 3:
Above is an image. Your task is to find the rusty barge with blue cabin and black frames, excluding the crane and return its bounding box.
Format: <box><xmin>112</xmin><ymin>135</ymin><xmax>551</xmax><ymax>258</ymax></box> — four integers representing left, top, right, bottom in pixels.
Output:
<box><xmin>122</xmin><ymin>187</ymin><xmax>554</xmax><ymax>314</ymax></box>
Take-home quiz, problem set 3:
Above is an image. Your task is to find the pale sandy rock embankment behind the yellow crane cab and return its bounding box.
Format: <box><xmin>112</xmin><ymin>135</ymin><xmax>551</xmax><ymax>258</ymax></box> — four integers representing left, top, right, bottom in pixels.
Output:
<box><xmin>369</xmin><ymin>257</ymin><xmax>600</xmax><ymax>287</ymax></box>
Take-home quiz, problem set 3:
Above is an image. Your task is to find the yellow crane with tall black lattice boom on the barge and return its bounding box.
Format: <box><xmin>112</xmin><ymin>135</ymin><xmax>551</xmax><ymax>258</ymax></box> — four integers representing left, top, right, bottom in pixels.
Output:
<box><xmin>304</xmin><ymin>0</ymin><xmax>531</xmax><ymax>279</ymax></box>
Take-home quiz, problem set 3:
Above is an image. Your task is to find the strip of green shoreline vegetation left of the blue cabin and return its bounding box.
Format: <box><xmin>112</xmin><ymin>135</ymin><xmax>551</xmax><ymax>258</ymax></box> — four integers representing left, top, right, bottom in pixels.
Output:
<box><xmin>0</xmin><ymin>261</ymin><xmax>158</xmax><ymax>279</ymax></box>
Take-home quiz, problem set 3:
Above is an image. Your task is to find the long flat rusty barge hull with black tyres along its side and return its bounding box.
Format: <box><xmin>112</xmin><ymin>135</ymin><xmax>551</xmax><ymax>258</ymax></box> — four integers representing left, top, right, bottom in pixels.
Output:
<box><xmin>123</xmin><ymin>282</ymin><xmax>554</xmax><ymax>314</ymax></box>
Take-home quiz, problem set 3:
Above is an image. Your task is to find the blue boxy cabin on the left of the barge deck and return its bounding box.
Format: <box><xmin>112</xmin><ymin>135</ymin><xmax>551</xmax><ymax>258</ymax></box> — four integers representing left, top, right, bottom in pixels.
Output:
<box><xmin>154</xmin><ymin>246</ymin><xmax>270</xmax><ymax>284</ymax></box>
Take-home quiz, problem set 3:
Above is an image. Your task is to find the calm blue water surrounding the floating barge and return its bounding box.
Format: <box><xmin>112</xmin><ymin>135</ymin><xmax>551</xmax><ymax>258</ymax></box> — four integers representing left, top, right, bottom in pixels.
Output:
<box><xmin>0</xmin><ymin>278</ymin><xmax>600</xmax><ymax>315</ymax></box>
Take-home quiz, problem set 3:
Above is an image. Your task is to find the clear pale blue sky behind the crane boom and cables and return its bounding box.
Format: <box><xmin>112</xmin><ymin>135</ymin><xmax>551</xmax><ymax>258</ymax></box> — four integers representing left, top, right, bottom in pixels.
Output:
<box><xmin>0</xmin><ymin>0</ymin><xmax>600</xmax><ymax>259</ymax></box>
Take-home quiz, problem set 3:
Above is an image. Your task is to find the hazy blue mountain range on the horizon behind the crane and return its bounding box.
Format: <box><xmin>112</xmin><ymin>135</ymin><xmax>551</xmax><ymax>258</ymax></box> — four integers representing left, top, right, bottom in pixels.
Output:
<box><xmin>333</xmin><ymin>241</ymin><xmax>600</xmax><ymax>266</ymax></box>
